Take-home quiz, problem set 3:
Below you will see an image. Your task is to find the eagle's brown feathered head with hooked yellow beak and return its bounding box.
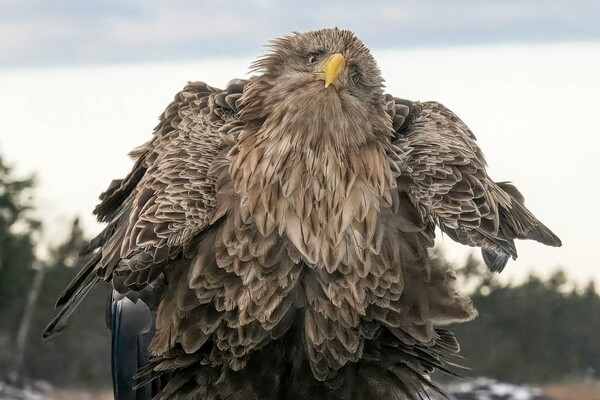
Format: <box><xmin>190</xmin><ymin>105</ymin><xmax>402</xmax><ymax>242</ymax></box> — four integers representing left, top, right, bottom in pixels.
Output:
<box><xmin>242</xmin><ymin>28</ymin><xmax>391</xmax><ymax>150</ymax></box>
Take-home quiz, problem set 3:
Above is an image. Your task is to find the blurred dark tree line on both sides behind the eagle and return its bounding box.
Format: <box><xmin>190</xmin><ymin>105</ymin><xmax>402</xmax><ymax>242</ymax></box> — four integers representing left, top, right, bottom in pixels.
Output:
<box><xmin>0</xmin><ymin>149</ymin><xmax>600</xmax><ymax>388</ymax></box>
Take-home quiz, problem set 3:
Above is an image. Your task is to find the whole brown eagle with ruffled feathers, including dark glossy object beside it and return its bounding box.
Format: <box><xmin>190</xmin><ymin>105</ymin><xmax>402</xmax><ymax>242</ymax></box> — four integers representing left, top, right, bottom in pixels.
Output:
<box><xmin>43</xmin><ymin>28</ymin><xmax>561</xmax><ymax>400</ymax></box>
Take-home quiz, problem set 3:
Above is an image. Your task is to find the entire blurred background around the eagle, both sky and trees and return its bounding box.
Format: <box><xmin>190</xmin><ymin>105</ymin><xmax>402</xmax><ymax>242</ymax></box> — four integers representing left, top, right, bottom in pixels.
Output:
<box><xmin>0</xmin><ymin>0</ymin><xmax>600</xmax><ymax>400</ymax></box>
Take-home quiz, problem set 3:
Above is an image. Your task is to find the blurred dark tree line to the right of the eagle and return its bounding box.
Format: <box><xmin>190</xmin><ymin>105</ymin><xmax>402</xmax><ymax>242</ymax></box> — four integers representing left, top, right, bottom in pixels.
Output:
<box><xmin>452</xmin><ymin>256</ymin><xmax>600</xmax><ymax>383</ymax></box>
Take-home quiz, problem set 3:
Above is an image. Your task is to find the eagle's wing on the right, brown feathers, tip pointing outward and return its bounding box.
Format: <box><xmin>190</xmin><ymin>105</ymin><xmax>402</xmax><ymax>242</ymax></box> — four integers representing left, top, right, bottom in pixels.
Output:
<box><xmin>388</xmin><ymin>99</ymin><xmax>561</xmax><ymax>271</ymax></box>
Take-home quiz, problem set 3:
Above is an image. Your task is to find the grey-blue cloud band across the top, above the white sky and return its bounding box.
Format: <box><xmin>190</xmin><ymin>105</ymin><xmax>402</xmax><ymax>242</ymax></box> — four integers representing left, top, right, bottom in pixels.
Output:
<box><xmin>0</xmin><ymin>0</ymin><xmax>600</xmax><ymax>67</ymax></box>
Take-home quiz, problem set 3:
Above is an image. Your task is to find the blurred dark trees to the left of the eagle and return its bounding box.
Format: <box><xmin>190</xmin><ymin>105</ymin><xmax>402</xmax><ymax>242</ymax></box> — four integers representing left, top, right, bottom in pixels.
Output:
<box><xmin>0</xmin><ymin>155</ymin><xmax>110</xmax><ymax>388</ymax></box>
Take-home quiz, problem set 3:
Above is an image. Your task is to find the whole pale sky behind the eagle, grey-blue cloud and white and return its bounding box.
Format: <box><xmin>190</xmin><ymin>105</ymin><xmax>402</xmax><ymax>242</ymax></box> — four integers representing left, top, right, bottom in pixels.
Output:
<box><xmin>0</xmin><ymin>0</ymin><xmax>600</xmax><ymax>283</ymax></box>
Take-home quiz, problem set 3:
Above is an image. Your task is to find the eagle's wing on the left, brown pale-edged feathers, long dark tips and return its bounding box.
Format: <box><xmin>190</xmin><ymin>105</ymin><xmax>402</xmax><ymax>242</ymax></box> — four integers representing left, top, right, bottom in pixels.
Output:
<box><xmin>43</xmin><ymin>80</ymin><xmax>245</xmax><ymax>337</ymax></box>
